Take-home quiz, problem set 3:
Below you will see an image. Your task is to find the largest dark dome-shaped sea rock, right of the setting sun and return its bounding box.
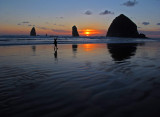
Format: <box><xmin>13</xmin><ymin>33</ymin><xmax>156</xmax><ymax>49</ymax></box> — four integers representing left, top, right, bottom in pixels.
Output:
<box><xmin>106</xmin><ymin>14</ymin><xmax>146</xmax><ymax>38</ymax></box>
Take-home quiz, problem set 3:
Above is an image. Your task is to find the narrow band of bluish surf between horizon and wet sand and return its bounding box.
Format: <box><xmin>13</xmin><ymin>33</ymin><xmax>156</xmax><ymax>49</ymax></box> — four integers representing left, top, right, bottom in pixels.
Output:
<box><xmin>0</xmin><ymin>36</ymin><xmax>159</xmax><ymax>46</ymax></box>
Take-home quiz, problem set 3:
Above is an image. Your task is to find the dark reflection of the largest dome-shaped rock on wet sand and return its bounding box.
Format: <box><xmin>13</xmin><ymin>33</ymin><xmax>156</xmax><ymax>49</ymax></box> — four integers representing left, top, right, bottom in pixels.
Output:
<box><xmin>107</xmin><ymin>43</ymin><xmax>138</xmax><ymax>61</ymax></box>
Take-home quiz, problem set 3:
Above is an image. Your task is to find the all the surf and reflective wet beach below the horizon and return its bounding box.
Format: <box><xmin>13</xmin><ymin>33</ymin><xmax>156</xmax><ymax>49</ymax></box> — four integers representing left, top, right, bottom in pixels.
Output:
<box><xmin>0</xmin><ymin>36</ymin><xmax>160</xmax><ymax>117</ymax></box>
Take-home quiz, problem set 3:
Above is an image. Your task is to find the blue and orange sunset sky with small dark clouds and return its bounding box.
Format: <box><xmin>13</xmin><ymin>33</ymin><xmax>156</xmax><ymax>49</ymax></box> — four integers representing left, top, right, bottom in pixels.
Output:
<box><xmin>0</xmin><ymin>0</ymin><xmax>160</xmax><ymax>37</ymax></box>
